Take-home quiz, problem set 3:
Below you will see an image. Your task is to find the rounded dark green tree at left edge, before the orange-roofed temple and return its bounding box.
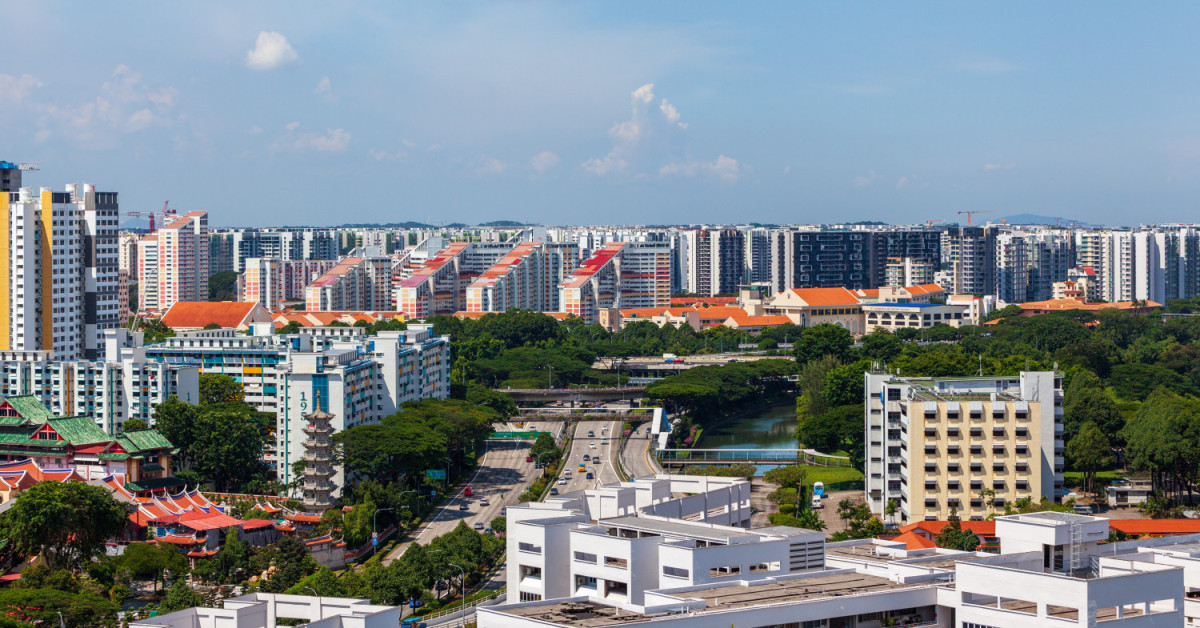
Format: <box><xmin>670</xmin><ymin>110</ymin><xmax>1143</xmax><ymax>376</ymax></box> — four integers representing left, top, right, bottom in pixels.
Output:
<box><xmin>0</xmin><ymin>482</ymin><xmax>125</xmax><ymax>569</ymax></box>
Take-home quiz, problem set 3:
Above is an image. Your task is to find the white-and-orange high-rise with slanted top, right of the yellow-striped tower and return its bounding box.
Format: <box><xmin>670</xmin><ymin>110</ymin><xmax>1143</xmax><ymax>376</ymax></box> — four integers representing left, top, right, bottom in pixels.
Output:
<box><xmin>138</xmin><ymin>211</ymin><xmax>209</xmax><ymax>310</ymax></box>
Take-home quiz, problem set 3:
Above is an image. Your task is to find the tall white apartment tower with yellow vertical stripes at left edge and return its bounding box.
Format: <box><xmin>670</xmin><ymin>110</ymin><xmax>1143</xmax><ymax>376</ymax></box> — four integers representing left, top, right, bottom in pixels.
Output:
<box><xmin>0</xmin><ymin>184</ymin><xmax>119</xmax><ymax>359</ymax></box>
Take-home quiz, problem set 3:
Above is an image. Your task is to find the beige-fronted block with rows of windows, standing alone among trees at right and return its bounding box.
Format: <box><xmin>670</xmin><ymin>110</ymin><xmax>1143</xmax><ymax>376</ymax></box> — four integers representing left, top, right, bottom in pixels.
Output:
<box><xmin>864</xmin><ymin>371</ymin><xmax>1063</xmax><ymax>522</ymax></box>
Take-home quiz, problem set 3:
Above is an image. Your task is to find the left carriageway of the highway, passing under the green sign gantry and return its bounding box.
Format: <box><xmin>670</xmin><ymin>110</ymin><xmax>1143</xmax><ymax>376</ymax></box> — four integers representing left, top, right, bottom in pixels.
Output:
<box><xmin>384</xmin><ymin>423</ymin><xmax>549</xmax><ymax>564</ymax></box>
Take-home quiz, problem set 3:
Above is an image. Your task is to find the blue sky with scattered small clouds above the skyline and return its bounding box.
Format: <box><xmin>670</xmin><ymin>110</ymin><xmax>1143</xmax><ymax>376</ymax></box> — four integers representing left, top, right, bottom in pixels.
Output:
<box><xmin>0</xmin><ymin>1</ymin><xmax>1200</xmax><ymax>226</ymax></box>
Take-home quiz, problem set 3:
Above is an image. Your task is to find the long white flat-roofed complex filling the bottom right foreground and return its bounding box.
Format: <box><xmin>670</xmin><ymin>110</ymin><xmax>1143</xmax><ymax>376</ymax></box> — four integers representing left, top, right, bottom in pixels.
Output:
<box><xmin>476</xmin><ymin>513</ymin><xmax>1200</xmax><ymax>628</ymax></box>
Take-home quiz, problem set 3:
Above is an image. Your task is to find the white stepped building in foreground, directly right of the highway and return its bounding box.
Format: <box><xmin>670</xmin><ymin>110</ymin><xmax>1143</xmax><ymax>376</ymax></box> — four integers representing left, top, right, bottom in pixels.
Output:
<box><xmin>506</xmin><ymin>476</ymin><xmax>824</xmax><ymax>604</ymax></box>
